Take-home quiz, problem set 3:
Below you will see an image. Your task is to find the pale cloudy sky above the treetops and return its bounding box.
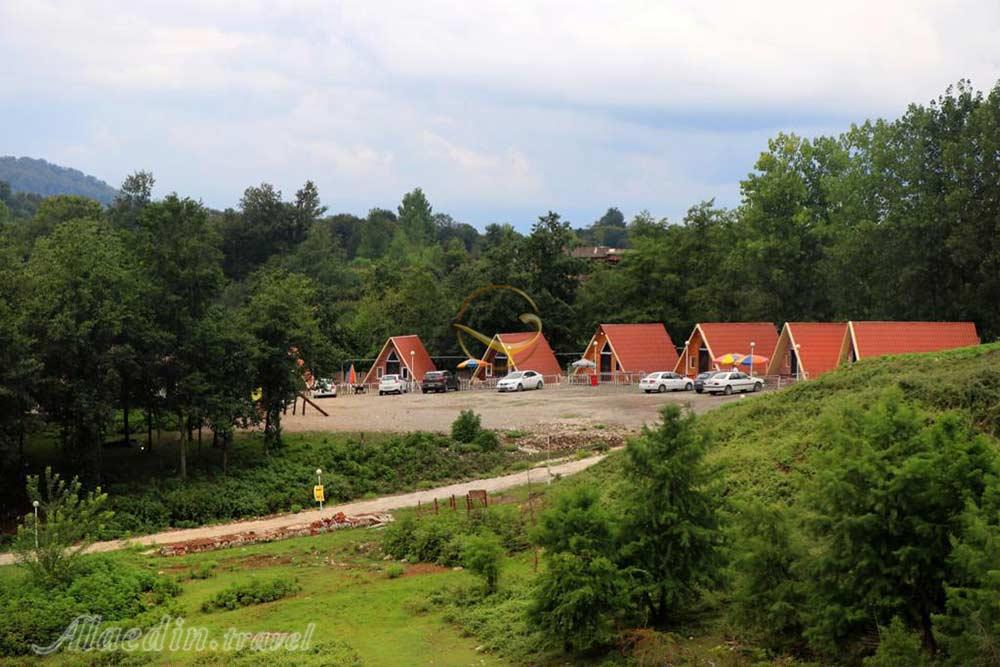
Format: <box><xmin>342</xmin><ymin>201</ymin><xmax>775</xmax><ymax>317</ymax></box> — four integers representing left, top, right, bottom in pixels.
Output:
<box><xmin>0</xmin><ymin>0</ymin><xmax>1000</xmax><ymax>229</ymax></box>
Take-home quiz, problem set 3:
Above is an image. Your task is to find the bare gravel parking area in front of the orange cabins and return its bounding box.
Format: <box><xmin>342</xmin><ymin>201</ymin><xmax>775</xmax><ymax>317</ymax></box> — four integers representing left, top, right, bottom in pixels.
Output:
<box><xmin>281</xmin><ymin>386</ymin><xmax>740</xmax><ymax>432</ymax></box>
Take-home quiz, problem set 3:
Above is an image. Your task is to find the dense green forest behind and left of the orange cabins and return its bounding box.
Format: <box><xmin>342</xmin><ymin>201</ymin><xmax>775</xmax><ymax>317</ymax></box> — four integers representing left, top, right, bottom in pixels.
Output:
<box><xmin>0</xmin><ymin>82</ymin><xmax>1000</xmax><ymax>490</ymax></box>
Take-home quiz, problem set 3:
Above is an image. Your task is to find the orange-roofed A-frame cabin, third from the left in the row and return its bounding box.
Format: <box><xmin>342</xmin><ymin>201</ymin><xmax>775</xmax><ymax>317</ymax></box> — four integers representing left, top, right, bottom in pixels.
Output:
<box><xmin>577</xmin><ymin>322</ymin><xmax>677</xmax><ymax>378</ymax></box>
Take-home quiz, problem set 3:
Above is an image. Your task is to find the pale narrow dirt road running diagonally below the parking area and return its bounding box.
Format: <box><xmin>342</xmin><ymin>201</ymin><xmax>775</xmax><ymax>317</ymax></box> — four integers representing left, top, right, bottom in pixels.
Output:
<box><xmin>0</xmin><ymin>454</ymin><xmax>604</xmax><ymax>565</ymax></box>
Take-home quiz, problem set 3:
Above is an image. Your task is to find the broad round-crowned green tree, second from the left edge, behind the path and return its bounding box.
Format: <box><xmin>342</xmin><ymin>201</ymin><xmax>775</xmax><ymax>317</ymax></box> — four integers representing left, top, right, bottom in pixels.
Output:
<box><xmin>26</xmin><ymin>220</ymin><xmax>148</xmax><ymax>479</ymax></box>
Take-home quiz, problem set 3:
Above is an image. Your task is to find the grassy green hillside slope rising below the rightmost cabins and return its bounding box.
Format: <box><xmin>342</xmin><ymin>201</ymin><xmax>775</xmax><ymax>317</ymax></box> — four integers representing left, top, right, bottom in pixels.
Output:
<box><xmin>570</xmin><ymin>343</ymin><xmax>1000</xmax><ymax>502</ymax></box>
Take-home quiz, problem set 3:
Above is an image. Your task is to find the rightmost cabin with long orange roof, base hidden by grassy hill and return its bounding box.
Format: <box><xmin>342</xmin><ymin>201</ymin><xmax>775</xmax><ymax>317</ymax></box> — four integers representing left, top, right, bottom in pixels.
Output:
<box><xmin>839</xmin><ymin>322</ymin><xmax>979</xmax><ymax>363</ymax></box>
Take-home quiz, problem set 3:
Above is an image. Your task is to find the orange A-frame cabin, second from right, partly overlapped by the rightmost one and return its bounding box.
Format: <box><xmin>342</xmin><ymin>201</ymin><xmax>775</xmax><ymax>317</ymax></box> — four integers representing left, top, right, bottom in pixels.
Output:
<box><xmin>767</xmin><ymin>322</ymin><xmax>847</xmax><ymax>380</ymax></box>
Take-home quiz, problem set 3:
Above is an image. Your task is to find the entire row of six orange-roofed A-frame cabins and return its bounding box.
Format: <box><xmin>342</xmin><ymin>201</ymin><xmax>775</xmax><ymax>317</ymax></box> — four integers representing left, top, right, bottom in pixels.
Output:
<box><xmin>364</xmin><ymin>321</ymin><xmax>979</xmax><ymax>384</ymax></box>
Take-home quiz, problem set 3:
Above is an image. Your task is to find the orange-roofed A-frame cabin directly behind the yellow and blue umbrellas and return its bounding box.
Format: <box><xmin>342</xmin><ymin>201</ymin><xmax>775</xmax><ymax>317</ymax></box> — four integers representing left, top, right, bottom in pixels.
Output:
<box><xmin>674</xmin><ymin>322</ymin><xmax>778</xmax><ymax>376</ymax></box>
